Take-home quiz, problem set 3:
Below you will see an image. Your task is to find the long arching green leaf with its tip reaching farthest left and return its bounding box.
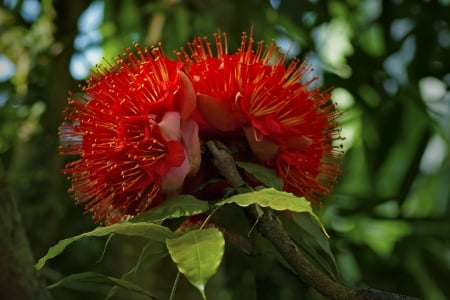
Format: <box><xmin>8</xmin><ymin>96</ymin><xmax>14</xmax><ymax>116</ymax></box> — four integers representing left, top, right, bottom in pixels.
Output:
<box><xmin>36</xmin><ymin>222</ymin><xmax>176</xmax><ymax>270</ymax></box>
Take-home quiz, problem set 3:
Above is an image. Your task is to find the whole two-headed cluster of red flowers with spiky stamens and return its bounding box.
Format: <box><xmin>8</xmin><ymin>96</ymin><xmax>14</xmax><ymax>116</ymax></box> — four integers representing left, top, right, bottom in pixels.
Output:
<box><xmin>60</xmin><ymin>33</ymin><xmax>341</xmax><ymax>224</ymax></box>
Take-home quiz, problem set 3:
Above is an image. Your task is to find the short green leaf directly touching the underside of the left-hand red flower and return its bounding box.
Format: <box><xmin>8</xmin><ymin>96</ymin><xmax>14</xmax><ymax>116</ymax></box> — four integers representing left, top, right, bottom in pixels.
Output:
<box><xmin>131</xmin><ymin>195</ymin><xmax>209</xmax><ymax>222</ymax></box>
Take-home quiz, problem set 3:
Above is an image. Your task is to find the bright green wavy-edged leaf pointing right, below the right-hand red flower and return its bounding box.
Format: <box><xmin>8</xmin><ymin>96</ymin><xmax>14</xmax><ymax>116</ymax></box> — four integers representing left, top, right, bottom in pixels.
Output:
<box><xmin>216</xmin><ymin>188</ymin><xmax>328</xmax><ymax>237</ymax></box>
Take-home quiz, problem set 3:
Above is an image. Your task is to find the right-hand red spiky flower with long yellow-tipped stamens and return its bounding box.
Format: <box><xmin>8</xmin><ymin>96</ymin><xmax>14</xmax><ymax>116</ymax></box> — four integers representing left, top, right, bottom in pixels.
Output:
<box><xmin>178</xmin><ymin>33</ymin><xmax>341</xmax><ymax>203</ymax></box>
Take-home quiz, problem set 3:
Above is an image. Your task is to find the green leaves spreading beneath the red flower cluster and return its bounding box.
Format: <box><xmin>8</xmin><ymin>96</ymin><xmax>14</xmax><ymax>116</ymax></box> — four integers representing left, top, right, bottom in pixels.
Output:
<box><xmin>36</xmin><ymin>186</ymin><xmax>326</xmax><ymax>299</ymax></box>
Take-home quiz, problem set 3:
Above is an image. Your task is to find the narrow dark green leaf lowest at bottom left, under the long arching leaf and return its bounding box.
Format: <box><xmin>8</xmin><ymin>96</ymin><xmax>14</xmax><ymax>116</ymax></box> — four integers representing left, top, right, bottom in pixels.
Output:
<box><xmin>48</xmin><ymin>272</ymin><xmax>156</xmax><ymax>299</ymax></box>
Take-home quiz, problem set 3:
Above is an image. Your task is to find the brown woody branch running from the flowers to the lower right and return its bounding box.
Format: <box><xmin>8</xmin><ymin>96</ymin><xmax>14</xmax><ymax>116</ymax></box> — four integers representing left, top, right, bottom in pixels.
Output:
<box><xmin>206</xmin><ymin>141</ymin><xmax>417</xmax><ymax>300</ymax></box>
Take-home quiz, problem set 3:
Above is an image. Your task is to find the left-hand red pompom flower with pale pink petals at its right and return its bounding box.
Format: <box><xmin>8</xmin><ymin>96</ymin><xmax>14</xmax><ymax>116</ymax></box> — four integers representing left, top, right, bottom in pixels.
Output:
<box><xmin>60</xmin><ymin>45</ymin><xmax>200</xmax><ymax>223</ymax></box>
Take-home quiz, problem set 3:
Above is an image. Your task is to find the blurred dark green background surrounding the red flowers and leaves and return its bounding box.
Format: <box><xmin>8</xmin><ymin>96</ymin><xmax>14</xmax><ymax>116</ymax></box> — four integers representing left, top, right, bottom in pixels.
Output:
<box><xmin>0</xmin><ymin>0</ymin><xmax>450</xmax><ymax>300</ymax></box>
